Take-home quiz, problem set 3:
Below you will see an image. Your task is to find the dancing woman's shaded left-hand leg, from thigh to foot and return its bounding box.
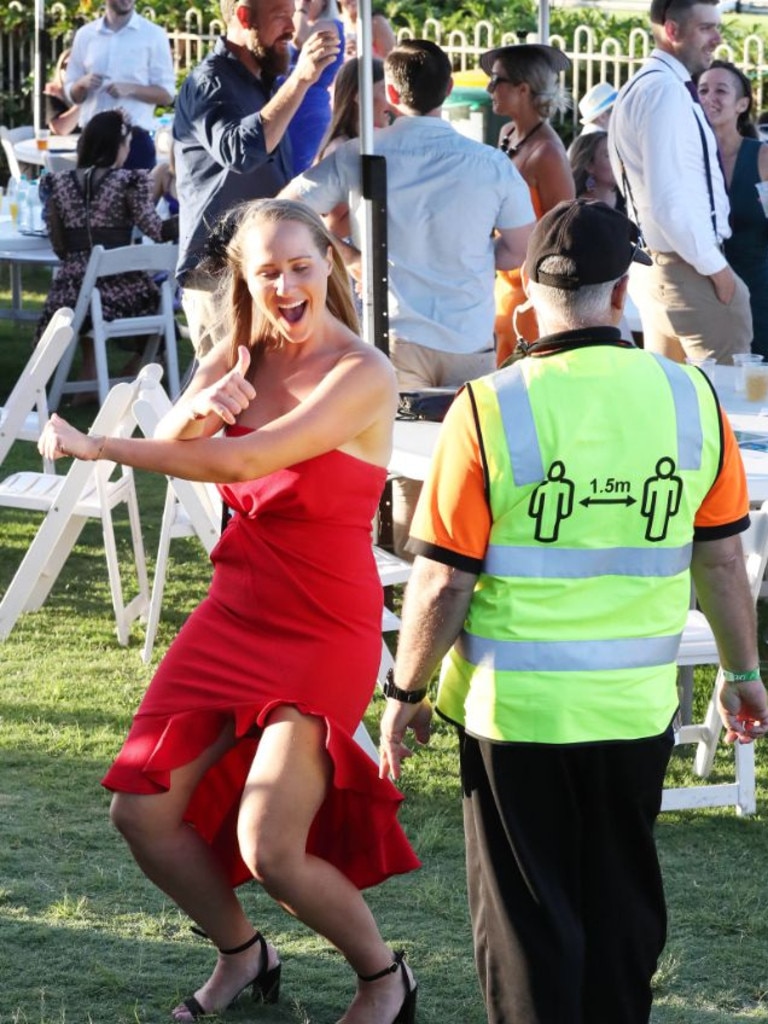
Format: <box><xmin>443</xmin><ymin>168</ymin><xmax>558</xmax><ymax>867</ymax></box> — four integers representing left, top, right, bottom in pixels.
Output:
<box><xmin>112</xmin><ymin>727</ymin><xmax>278</xmax><ymax>1021</ymax></box>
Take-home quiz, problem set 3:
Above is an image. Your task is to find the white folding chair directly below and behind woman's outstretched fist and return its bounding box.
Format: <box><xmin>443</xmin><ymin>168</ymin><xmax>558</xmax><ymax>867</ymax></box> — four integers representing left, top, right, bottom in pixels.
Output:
<box><xmin>0</xmin><ymin>366</ymin><xmax>160</xmax><ymax>645</ymax></box>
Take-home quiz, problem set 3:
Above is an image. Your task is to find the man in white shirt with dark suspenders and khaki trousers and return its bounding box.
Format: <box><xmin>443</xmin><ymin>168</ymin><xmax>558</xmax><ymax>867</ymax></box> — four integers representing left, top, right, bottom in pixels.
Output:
<box><xmin>608</xmin><ymin>0</ymin><xmax>752</xmax><ymax>362</ymax></box>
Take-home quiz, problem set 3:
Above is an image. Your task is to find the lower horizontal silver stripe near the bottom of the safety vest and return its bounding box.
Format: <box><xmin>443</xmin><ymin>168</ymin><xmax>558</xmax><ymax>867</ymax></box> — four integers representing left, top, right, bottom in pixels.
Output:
<box><xmin>456</xmin><ymin>632</ymin><xmax>680</xmax><ymax>672</ymax></box>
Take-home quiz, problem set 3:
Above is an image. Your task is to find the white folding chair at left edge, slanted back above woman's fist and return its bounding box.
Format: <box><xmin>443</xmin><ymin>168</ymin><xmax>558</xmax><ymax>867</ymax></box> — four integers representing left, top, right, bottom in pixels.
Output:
<box><xmin>0</xmin><ymin>308</ymin><xmax>74</xmax><ymax>473</ymax></box>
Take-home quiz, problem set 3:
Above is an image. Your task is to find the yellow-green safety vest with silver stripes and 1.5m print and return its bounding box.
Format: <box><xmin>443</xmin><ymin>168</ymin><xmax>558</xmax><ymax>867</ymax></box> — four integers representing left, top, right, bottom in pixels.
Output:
<box><xmin>437</xmin><ymin>344</ymin><xmax>722</xmax><ymax>743</ymax></box>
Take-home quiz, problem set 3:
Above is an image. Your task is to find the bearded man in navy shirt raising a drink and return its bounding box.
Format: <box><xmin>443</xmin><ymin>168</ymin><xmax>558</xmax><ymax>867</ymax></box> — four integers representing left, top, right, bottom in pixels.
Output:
<box><xmin>173</xmin><ymin>0</ymin><xmax>339</xmax><ymax>356</ymax></box>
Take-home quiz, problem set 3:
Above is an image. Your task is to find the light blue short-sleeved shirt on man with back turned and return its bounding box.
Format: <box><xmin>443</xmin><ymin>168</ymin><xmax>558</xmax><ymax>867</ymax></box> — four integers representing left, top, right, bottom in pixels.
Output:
<box><xmin>289</xmin><ymin>117</ymin><xmax>535</xmax><ymax>354</ymax></box>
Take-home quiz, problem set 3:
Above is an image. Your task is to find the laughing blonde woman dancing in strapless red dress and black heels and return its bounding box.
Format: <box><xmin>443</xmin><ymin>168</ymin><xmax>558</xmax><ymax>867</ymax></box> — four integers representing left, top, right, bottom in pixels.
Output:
<box><xmin>40</xmin><ymin>200</ymin><xmax>419</xmax><ymax>1024</ymax></box>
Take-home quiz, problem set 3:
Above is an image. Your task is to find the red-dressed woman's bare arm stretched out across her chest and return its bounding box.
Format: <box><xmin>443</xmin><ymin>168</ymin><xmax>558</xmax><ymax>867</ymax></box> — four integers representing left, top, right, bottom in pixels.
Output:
<box><xmin>38</xmin><ymin>335</ymin><xmax>397</xmax><ymax>483</ymax></box>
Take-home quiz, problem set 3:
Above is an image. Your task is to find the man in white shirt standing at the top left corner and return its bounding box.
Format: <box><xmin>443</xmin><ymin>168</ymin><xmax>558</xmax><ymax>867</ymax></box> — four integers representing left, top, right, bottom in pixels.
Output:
<box><xmin>66</xmin><ymin>0</ymin><xmax>176</xmax><ymax>168</ymax></box>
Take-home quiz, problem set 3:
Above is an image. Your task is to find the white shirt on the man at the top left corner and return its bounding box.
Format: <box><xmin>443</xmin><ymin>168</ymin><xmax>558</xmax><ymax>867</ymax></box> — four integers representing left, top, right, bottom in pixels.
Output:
<box><xmin>67</xmin><ymin>12</ymin><xmax>176</xmax><ymax>131</ymax></box>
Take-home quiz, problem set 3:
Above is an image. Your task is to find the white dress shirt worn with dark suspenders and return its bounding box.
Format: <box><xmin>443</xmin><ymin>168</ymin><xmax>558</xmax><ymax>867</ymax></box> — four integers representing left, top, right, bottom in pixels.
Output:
<box><xmin>608</xmin><ymin>49</ymin><xmax>731</xmax><ymax>275</ymax></box>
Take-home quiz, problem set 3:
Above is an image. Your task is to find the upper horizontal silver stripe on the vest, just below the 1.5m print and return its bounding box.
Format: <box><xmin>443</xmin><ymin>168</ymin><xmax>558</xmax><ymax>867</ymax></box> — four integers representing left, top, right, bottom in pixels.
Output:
<box><xmin>482</xmin><ymin>544</ymin><xmax>693</xmax><ymax>580</ymax></box>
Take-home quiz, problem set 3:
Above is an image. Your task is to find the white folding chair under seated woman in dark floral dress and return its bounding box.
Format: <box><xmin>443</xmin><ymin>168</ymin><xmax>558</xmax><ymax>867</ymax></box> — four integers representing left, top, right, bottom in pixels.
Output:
<box><xmin>48</xmin><ymin>243</ymin><xmax>179</xmax><ymax>410</ymax></box>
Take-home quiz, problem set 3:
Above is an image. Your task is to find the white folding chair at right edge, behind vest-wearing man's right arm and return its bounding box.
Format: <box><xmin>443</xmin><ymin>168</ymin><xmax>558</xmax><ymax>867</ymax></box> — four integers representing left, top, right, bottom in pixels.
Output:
<box><xmin>662</xmin><ymin>502</ymin><xmax>768</xmax><ymax>814</ymax></box>
